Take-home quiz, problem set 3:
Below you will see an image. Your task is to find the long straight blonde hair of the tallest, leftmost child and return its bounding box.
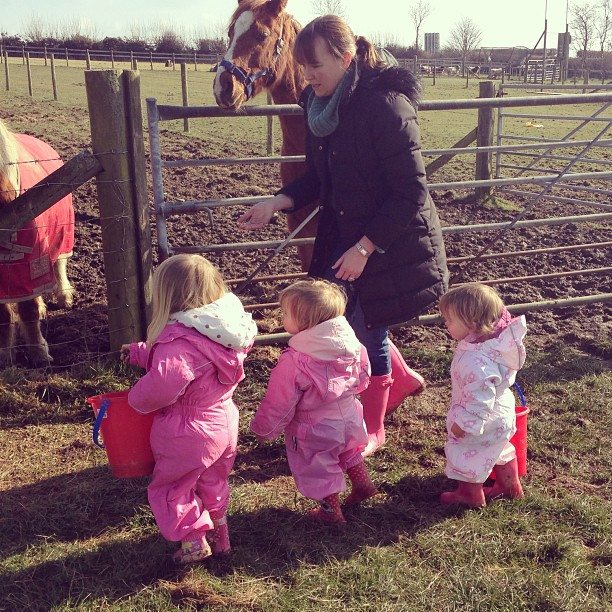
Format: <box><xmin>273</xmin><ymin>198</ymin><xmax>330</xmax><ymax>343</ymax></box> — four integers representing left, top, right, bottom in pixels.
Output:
<box><xmin>147</xmin><ymin>253</ymin><xmax>227</xmax><ymax>345</ymax></box>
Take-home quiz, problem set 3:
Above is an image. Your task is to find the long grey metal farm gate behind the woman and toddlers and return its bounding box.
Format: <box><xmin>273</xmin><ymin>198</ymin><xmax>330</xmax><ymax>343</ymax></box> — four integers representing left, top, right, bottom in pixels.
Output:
<box><xmin>147</xmin><ymin>90</ymin><xmax>612</xmax><ymax>343</ymax></box>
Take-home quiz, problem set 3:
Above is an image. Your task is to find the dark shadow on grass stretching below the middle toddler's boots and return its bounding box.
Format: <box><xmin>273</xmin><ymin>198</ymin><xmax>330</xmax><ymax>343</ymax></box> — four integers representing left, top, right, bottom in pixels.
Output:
<box><xmin>208</xmin><ymin>476</ymin><xmax>458</xmax><ymax>582</ymax></box>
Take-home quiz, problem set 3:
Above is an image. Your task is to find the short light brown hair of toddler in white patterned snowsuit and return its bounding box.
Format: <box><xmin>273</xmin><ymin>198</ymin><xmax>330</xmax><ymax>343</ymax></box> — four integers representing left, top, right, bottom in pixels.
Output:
<box><xmin>440</xmin><ymin>283</ymin><xmax>504</xmax><ymax>334</ymax></box>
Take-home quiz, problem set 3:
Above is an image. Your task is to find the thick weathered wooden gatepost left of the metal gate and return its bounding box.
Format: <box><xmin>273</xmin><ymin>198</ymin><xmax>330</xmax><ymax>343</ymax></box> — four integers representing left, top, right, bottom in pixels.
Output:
<box><xmin>85</xmin><ymin>70</ymin><xmax>150</xmax><ymax>351</ymax></box>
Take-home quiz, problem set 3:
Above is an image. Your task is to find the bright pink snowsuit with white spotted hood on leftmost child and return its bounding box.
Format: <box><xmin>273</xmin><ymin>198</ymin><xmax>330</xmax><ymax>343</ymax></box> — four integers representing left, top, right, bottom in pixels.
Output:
<box><xmin>128</xmin><ymin>293</ymin><xmax>257</xmax><ymax>541</ymax></box>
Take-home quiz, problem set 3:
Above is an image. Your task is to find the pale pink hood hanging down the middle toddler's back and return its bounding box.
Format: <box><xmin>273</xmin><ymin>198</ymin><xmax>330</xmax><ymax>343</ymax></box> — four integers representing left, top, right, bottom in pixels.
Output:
<box><xmin>289</xmin><ymin>317</ymin><xmax>367</xmax><ymax>397</ymax></box>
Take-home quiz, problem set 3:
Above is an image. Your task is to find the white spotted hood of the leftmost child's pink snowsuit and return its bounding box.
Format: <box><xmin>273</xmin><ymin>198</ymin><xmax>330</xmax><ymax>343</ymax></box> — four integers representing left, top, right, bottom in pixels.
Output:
<box><xmin>170</xmin><ymin>293</ymin><xmax>257</xmax><ymax>350</ymax></box>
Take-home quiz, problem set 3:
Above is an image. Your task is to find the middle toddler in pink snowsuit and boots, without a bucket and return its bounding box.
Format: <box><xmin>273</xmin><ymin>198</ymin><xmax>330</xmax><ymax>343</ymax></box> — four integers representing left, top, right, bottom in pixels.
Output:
<box><xmin>251</xmin><ymin>280</ymin><xmax>377</xmax><ymax>523</ymax></box>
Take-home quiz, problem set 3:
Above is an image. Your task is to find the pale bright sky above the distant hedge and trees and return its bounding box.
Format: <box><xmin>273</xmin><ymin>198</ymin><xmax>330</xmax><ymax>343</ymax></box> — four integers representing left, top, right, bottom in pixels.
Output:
<box><xmin>0</xmin><ymin>0</ymin><xmax>567</xmax><ymax>48</ymax></box>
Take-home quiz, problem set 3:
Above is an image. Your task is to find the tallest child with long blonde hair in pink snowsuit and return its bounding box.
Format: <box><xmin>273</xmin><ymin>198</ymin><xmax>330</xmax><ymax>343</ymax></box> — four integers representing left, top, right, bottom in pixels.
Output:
<box><xmin>122</xmin><ymin>255</ymin><xmax>257</xmax><ymax>563</ymax></box>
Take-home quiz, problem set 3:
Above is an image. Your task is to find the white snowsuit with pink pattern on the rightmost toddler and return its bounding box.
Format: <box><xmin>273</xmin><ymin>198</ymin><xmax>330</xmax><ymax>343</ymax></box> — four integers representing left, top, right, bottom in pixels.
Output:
<box><xmin>444</xmin><ymin>311</ymin><xmax>527</xmax><ymax>483</ymax></box>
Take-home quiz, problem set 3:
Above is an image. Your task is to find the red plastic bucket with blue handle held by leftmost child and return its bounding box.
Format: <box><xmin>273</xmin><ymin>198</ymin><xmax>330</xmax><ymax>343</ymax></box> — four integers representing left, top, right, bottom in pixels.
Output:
<box><xmin>85</xmin><ymin>391</ymin><xmax>155</xmax><ymax>478</ymax></box>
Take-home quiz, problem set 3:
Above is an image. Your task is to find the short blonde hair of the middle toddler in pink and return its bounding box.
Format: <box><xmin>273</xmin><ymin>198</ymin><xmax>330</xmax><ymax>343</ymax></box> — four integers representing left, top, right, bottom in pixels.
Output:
<box><xmin>279</xmin><ymin>279</ymin><xmax>346</xmax><ymax>331</ymax></box>
